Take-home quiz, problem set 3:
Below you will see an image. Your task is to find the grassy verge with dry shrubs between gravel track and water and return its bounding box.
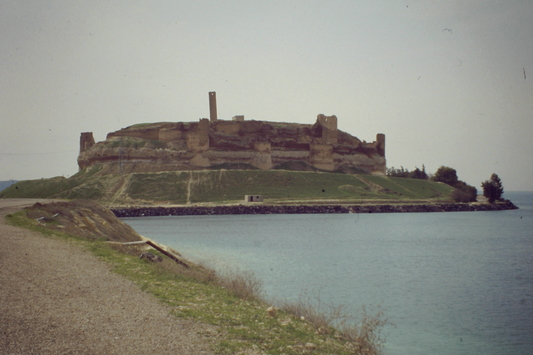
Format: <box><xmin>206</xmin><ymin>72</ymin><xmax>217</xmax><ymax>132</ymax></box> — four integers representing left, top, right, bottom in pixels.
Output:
<box><xmin>7</xmin><ymin>205</ymin><xmax>386</xmax><ymax>355</ymax></box>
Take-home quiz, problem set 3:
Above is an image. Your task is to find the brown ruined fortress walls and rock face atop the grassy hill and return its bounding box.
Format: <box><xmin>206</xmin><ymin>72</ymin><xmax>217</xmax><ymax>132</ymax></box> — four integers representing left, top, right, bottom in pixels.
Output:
<box><xmin>78</xmin><ymin>115</ymin><xmax>386</xmax><ymax>175</ymax></box>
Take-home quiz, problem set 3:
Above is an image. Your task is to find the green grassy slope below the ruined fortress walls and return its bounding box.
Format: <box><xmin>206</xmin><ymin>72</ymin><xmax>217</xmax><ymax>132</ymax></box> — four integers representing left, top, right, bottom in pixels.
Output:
<box><xmin>0</xmin><ymin>167</ymin><xmax>453</xmax><ymax>205</ymax></box>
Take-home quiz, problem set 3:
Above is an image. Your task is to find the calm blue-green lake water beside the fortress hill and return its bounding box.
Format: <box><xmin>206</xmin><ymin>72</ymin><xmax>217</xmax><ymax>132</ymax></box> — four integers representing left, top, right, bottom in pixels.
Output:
<box><xmin>124</xmin><ymin>192</ymin><xmax>533</xmax><ymax>355</ymax></box>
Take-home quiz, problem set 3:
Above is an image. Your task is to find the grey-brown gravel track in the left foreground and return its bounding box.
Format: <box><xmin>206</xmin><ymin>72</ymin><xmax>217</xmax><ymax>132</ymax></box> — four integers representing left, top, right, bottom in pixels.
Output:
<box><xmin>0</xmin><ymin>199</ymin><xmax>216</xmax><ymax>355</ymax></box>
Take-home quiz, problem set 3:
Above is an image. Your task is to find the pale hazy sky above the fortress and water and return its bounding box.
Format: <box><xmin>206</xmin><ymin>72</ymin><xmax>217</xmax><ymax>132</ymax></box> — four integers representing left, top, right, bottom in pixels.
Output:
<box><xmin>0</xmin><ymin>0</ymin><xmax>533</xmax><ymax>190</ymax></box>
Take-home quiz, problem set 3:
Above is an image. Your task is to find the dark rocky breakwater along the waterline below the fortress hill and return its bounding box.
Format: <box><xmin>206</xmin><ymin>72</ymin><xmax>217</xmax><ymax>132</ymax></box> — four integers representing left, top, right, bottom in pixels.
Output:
<box><xmin>111</xmin><ymin>201</ymin><xmax>518</xmax><ymax>218</ymax></box>
